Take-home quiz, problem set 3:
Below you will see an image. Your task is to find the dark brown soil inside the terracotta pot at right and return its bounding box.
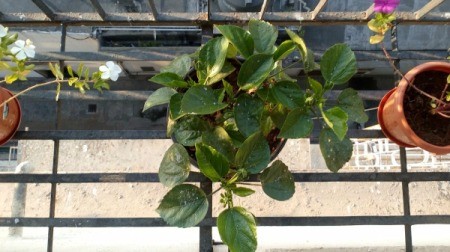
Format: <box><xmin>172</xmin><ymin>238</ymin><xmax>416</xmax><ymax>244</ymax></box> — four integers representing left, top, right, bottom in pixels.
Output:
<box><xmin>403</xmin><ymin>71</ymin><xmax>450</xmax><ymax>146</ymax></box>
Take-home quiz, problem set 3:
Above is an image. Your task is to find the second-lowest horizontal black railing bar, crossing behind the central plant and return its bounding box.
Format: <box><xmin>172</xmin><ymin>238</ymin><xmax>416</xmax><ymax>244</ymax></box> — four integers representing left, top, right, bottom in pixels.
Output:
<box><xmin>0</xmin><ymin>171</ymin><xmax>450</xmax><ymax>183</ymax></box>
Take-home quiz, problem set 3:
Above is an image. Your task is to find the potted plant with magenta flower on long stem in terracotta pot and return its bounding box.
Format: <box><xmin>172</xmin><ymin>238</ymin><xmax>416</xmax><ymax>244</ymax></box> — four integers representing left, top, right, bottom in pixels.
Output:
<box><xmin>368</xmin><ymin>0</ymin><xmax>450</xmax><ymax>155</ymax></box>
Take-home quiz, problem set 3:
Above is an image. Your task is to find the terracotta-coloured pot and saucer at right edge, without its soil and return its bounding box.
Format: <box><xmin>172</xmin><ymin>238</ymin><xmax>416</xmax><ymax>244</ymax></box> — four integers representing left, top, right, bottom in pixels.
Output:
<box><xmin>378</xmin><ymin>62</ymin><xmax>450</xmax><ymax>155</ymax></box>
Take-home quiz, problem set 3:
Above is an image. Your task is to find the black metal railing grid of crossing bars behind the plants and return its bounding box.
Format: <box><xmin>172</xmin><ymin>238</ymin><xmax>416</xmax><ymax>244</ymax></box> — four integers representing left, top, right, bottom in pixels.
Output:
<box><xmin>0</xmin><ymin>0</ymin><xmax>450</xmax><ymax>251</ymax></box>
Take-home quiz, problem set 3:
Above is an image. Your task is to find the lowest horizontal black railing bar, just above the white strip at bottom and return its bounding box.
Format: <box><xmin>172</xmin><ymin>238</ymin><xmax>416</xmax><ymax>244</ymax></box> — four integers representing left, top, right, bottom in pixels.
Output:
<box><xmin>0</xmin><ymin>215</ymin><xmax>450</xmax><ymax>228</ymax></box>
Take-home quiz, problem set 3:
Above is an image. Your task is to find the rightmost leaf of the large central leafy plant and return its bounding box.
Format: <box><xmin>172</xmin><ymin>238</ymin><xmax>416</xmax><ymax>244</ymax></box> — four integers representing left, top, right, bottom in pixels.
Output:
<box><xmin>338</xmin><ymin>88</ymin><xmax>369</xmax><ymax>123</ymax></box>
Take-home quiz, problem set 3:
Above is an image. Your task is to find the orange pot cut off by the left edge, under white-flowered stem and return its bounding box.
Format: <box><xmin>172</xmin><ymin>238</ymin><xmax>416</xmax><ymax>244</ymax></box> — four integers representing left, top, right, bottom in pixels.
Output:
<box><xmin>0</xmin><ymin>87</ymin><xmax>22</xmax><ymax>145</ymax></box>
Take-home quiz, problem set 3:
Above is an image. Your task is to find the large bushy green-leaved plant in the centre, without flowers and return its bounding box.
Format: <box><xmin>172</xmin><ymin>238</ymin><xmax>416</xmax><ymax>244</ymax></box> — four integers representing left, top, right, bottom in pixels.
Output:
<box><xmin>144</xmin><ymin>20</ymin><xmax>367</xmax><ymax>251</ymax></box>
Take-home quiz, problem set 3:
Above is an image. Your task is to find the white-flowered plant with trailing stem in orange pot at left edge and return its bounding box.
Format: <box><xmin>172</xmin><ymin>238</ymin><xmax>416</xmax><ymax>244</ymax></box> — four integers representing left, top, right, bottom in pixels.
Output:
<box><xmin>0</xmin><ymin>25</ymin><xmax>122</xmax><ymax>145</ymax></box>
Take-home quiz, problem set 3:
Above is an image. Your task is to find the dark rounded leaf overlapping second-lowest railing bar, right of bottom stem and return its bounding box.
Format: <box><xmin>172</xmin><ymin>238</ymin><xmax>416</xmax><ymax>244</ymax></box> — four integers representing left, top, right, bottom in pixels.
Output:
<box><xmin>260</xmin><ymin>160</ymin><xmax>295</xmax><ymax>201</ymax></box>
